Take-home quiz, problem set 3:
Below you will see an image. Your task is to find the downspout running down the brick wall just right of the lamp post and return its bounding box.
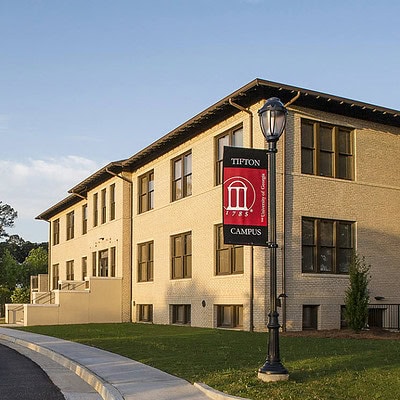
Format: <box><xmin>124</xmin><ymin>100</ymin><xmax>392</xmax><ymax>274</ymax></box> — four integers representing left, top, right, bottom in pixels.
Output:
<box><xmin>281</xmin><ymin>91</ymin><xmax>300</xmax><ymax>332</ymax></box>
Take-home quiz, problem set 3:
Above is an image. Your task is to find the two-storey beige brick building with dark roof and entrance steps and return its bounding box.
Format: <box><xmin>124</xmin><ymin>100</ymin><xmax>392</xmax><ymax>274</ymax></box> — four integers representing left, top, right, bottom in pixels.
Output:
<box><xmin>7</xmin><ymin>79</ymin><xmax>400</xmax><ymax>330</ymax></box>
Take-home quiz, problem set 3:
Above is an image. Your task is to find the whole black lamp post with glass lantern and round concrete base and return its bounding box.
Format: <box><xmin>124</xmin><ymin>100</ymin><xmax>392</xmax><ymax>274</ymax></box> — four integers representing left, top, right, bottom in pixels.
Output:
<box><xmin>258</xmin><ymin>97</ymin><xmax>289</xmax><ymax>382</ymax></box>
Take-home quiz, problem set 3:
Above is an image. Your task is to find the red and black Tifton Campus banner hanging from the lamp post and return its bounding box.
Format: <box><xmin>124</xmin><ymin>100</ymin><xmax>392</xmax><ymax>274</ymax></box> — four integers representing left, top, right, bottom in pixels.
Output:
<box><xmin>222</xmin><ymin>147</ymin><xmax>268</xmax><ymax>246</ymax></box>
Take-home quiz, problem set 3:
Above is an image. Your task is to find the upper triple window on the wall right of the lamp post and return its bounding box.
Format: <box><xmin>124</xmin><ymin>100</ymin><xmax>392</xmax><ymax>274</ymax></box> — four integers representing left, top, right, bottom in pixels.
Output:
<box><xmin>301</xmin><ymin>119</ymin><xmax>354</xmax><ymax>180</ymax></box>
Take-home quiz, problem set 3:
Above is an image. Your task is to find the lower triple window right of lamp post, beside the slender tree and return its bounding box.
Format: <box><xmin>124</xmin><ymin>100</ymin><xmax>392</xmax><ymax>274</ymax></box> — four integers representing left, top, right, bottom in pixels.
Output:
<box><xmin>302</xmin><ymin>218</ymin><xmax>354</xmax><ymax>274</ymax></box>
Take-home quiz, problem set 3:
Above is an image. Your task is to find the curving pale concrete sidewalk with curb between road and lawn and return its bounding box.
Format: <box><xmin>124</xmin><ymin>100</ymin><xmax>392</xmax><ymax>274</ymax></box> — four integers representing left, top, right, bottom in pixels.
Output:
<box><xmin>0</xmin><ymin>327</ymin><xmax>247</xmax><ymax>400</ymax></box>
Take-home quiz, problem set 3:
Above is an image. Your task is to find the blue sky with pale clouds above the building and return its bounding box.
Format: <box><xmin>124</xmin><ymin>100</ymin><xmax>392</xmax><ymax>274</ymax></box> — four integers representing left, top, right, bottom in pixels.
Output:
<box><xmin>0</xmin><ymin>0</ymin><xmax>400</xmax><ymax>242</ymax></box>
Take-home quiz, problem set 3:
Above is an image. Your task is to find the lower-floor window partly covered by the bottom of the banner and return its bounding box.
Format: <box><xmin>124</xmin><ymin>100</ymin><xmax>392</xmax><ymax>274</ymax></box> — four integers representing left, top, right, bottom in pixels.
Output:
<box><xmin>216</xmin><ymin>225</ymin><xmax>244</xmax><ymax>275</ymax></box>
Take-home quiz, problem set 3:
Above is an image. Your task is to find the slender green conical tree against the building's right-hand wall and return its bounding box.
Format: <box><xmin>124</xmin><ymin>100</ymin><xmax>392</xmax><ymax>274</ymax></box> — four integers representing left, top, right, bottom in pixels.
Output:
<box><xmin>345</xmin><ymin>253</ymin><xmax>371</xmax><ymax>332</ymax></box>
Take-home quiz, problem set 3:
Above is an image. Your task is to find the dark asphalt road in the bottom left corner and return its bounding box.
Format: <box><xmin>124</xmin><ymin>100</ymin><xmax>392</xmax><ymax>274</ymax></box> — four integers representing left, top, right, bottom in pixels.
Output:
<box><xmin>0</xmin><ymin>344</ymin><xmax>64</xmax><ymax>400</ymax></box>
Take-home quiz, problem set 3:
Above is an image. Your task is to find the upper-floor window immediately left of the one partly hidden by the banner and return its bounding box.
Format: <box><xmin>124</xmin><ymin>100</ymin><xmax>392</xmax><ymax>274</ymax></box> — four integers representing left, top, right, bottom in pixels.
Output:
<box><xmin>172</xmin><ymin>153</ymin><xmax>192</xmax><ymax>201</ymax></box>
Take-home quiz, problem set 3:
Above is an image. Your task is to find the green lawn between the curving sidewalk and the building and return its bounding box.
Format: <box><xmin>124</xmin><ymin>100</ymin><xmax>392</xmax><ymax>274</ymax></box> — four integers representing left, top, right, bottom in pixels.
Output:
<box><xmin>18</xmin><ymin>324</ymin><xmax>400</xmax><ymax>400</ymax></box>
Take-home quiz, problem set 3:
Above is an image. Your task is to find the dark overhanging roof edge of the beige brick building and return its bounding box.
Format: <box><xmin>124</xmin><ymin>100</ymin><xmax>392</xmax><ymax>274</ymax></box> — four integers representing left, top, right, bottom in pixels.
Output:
<box><xmin>36</xmin><ymin>79</ymin><xmax>400</xmax><ymax>220</ymax></box>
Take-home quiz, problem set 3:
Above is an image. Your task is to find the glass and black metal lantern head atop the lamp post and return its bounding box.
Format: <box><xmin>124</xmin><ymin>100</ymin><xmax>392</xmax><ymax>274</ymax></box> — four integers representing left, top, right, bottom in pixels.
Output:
<box><xmin>258</xmin><ymin>97</ymin><xmax>287</xmax><ymax>142</ymax></box>
